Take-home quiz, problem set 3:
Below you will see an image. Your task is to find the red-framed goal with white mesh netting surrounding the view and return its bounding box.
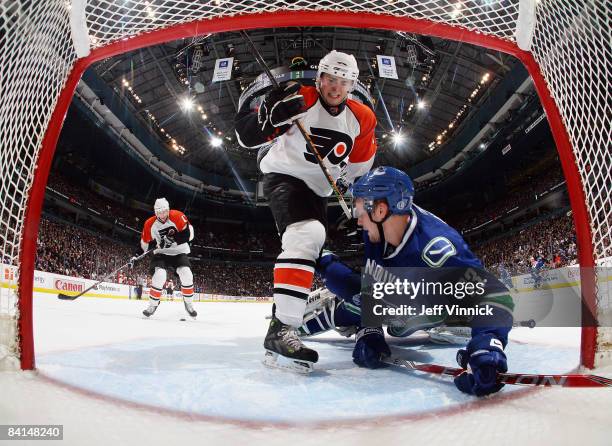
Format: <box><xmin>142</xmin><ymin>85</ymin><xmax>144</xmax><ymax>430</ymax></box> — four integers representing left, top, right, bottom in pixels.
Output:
<box><xmin>0</xmin><ymin>0</ymin><xmax>612</xmax><ymax>369</ymax></box>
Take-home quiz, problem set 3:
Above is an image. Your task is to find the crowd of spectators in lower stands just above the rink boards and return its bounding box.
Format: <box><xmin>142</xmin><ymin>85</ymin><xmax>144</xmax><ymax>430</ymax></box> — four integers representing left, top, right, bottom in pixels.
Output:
<box><xmin>36</xmin><ymin>209</ymin><xmax>577</xmax><ymax>296</ymax></box>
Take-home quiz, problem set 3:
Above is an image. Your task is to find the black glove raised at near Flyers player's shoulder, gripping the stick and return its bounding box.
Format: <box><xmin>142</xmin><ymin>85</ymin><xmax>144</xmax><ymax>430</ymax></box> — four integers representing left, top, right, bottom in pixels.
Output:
<box><xmin>258</xmin><ymin>82</ymin><xmax>306</xmax><ymax>129</ymax></box>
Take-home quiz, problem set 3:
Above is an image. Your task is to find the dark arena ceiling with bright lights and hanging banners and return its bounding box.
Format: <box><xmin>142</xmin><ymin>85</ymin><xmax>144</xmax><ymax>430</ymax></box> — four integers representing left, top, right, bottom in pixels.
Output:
<box><xmin>94</xmin><ymin>27</ymin><xmax>516</xmax><ymax>183</ymax></box>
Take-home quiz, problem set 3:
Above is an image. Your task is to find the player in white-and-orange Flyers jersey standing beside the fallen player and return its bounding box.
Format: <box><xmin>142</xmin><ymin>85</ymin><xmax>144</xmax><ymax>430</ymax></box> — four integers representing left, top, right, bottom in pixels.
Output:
<box><xmin>235</xmin><ymin>51</ymin><xmax>376</xmax><ymax>372</ymax></box>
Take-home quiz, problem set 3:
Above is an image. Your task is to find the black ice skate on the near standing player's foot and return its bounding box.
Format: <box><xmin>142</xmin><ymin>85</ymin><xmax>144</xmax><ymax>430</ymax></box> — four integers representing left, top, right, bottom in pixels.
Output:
<box><xmin>263</xmin><ymin>316</ymin><xmax>319</xmax><ymax>373</ymax></box>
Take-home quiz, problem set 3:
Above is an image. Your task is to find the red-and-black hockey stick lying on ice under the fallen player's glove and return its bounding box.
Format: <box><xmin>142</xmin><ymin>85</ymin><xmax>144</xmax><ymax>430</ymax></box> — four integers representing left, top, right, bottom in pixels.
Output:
<box><xmin>382</xmin><ymin>356</ymin><xmax>612</xmax><ymax>387</ymax></box>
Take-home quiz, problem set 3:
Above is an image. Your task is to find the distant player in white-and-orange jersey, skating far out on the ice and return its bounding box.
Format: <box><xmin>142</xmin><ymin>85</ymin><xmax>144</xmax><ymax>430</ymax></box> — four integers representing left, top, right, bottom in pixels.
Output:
<box><xmin>135</xmin><ymin>198</ymin><xmax>198</xmax><ymax>318</ymax></box>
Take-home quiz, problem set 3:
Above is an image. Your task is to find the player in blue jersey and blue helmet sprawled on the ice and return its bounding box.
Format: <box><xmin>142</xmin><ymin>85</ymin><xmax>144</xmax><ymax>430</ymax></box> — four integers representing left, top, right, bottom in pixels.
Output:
<box><xmin>300</xmin><ymin>167</ymin><xmax>513</xmax><ymax>396</ymax></box>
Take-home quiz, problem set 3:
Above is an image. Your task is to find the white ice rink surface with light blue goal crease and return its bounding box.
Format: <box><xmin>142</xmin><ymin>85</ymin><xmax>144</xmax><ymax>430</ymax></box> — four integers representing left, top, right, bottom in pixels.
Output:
<box><xmin>0</xmin><ymin>294</ymin><xmax>612</xmax><ymax>445</ymax></box>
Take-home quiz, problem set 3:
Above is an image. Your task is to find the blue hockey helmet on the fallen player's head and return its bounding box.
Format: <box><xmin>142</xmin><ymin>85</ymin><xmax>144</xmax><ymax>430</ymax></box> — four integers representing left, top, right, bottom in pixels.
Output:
<box><xmin>352</xmin><ymin>166</ymin><xmax>414</xmax><ymax>214</ymax></box>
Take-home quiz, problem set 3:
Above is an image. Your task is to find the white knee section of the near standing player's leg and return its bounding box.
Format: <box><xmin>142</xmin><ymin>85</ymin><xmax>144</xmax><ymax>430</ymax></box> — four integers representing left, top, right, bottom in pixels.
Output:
<box><xmin>280</xmin><ymin>220</ymin><xmax>325</xmax><ymax>260</ymax></box>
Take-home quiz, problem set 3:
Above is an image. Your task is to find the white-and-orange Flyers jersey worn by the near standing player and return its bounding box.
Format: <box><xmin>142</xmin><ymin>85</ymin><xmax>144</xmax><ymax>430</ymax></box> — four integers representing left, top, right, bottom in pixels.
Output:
<box><xmin>255</xmin><ymin>86</ymin><xmax>376</xmax><ymax>197</ymax></box>
